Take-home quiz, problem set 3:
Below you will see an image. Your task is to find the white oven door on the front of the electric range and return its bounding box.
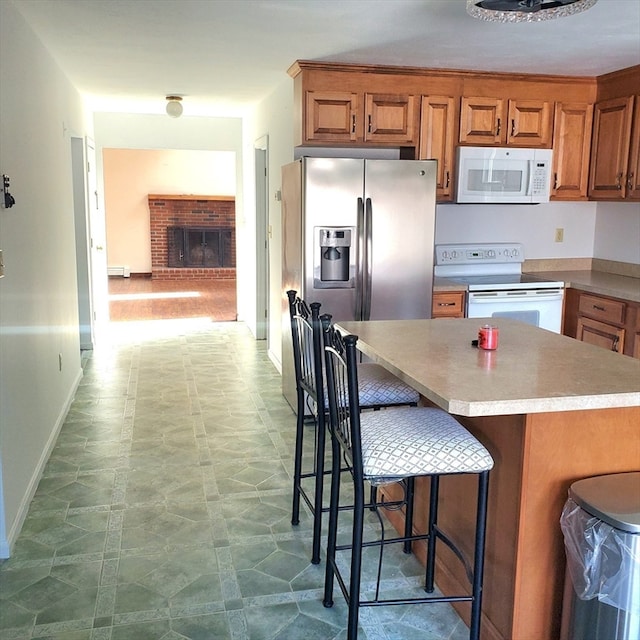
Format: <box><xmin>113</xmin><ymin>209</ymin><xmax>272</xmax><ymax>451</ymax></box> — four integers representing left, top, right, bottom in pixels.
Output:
<box><xmin>467</xmin><ymin>289</ymin><xmax>564</xmax><ymax>333</ymax></box>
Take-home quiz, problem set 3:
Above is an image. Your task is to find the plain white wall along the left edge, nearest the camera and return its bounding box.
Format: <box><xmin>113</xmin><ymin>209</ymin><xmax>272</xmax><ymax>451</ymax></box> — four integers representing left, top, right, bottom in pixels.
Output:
<box><xmin>0</xmin><ymin>2</ymin><xmax>91</xmax><ymax>557</ymax></box>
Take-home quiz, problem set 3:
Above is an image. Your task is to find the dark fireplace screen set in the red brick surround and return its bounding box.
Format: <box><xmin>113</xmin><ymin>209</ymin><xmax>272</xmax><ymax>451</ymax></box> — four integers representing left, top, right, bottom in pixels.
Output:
<box><xmin>167</xmin><ymin>227</ymin><xmax>236</xmax><ymax>268</ymax></box>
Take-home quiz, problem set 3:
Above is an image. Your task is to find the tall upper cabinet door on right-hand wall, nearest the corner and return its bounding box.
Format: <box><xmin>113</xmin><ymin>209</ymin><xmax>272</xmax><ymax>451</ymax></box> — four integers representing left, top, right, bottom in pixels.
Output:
<box><xmin>589</xmin><ymin>96</ymin><xmax>633</xmax><ymax>200</ymax></box>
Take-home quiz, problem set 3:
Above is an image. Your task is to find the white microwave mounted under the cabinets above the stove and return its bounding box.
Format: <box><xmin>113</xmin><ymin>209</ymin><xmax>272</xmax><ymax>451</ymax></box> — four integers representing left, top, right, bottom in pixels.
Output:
<box><xmin>456</xmin><ymin>147</ymin><xmax>552</xmax><ymax>204</ymax></box>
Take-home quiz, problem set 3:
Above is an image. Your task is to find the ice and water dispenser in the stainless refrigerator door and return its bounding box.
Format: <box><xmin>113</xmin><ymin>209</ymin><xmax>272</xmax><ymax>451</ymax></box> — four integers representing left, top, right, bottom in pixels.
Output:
<box><xmin>314</xmin><ymin>227</ymin><xmax>355</xmax><ymax>289</ymax></box>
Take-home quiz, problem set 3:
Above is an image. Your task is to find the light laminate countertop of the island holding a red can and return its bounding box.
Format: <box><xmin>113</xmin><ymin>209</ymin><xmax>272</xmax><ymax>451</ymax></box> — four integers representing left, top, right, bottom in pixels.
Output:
<box><xmin>338</xmin><ymin>318</ymin><xmax>640</xmax><ymax>416</ymax></box>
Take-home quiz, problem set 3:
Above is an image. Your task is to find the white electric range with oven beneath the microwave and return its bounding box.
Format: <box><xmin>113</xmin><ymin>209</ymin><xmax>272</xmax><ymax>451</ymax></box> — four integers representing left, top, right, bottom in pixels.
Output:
<box><xmin>434</xmin><ymin>243</ymin><xmax>564</xmax><ymax>333</ymax></box>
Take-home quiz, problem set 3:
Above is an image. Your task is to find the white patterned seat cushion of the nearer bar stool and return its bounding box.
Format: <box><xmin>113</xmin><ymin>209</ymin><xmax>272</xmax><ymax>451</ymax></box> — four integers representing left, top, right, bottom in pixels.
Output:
<box><xmin>360</xmin><ymin>407</ymin><xmax>493</xmax><ymax>484</ymax></box>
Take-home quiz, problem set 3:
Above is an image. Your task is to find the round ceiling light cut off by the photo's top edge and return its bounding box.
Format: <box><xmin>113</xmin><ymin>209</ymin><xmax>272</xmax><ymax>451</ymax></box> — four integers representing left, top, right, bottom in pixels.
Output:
<box><xmin>467</xmin><ymin>0</ymin><xmax>597</xmax><ymax>22</ymax></box>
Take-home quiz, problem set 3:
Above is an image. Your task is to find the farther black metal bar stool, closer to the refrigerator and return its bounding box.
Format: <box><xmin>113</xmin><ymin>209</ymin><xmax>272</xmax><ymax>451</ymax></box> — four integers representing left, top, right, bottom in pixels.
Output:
<box><xmin>287</xmin><ymin>290</ymin><xmax>420</xmax><ymax>564</ymax></box>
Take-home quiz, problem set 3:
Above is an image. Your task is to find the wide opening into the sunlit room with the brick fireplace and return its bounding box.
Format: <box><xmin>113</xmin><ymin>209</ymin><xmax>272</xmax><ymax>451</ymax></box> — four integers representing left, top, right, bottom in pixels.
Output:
<box><xmin>103</xmin><ymin>148</ymin><xmax>238</xmax><ymax>321</ymax></box>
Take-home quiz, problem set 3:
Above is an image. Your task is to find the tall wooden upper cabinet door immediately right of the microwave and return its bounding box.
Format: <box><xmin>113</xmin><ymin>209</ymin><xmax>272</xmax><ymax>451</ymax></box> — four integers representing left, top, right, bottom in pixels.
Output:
<box><xmin>551</xmin><ymin>102</ymin><xmax>593</xmax><ymax>200</ymax></box>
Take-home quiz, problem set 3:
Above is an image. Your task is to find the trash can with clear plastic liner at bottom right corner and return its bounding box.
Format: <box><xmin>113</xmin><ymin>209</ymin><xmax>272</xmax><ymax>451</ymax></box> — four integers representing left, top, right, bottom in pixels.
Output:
<box><xmin>560</xmin><ymin>472</ymin><xmax>640</xmax><ymax>640</ymax></box>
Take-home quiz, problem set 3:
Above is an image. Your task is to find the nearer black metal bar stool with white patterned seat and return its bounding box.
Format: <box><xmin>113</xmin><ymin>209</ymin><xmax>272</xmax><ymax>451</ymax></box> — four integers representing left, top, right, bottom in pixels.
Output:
<box><xmin>322</xmin><ymin>316</ymin><xmax>493</xmax><ymax>640</ymax></box>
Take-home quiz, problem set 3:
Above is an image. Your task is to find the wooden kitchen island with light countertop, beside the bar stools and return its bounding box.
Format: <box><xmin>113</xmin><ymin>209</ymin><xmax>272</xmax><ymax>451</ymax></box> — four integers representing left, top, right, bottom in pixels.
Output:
<box><xmin>338</xmin><ymin>319</ymin><xmax>640</xmax><ymax>640</ymax></box>
